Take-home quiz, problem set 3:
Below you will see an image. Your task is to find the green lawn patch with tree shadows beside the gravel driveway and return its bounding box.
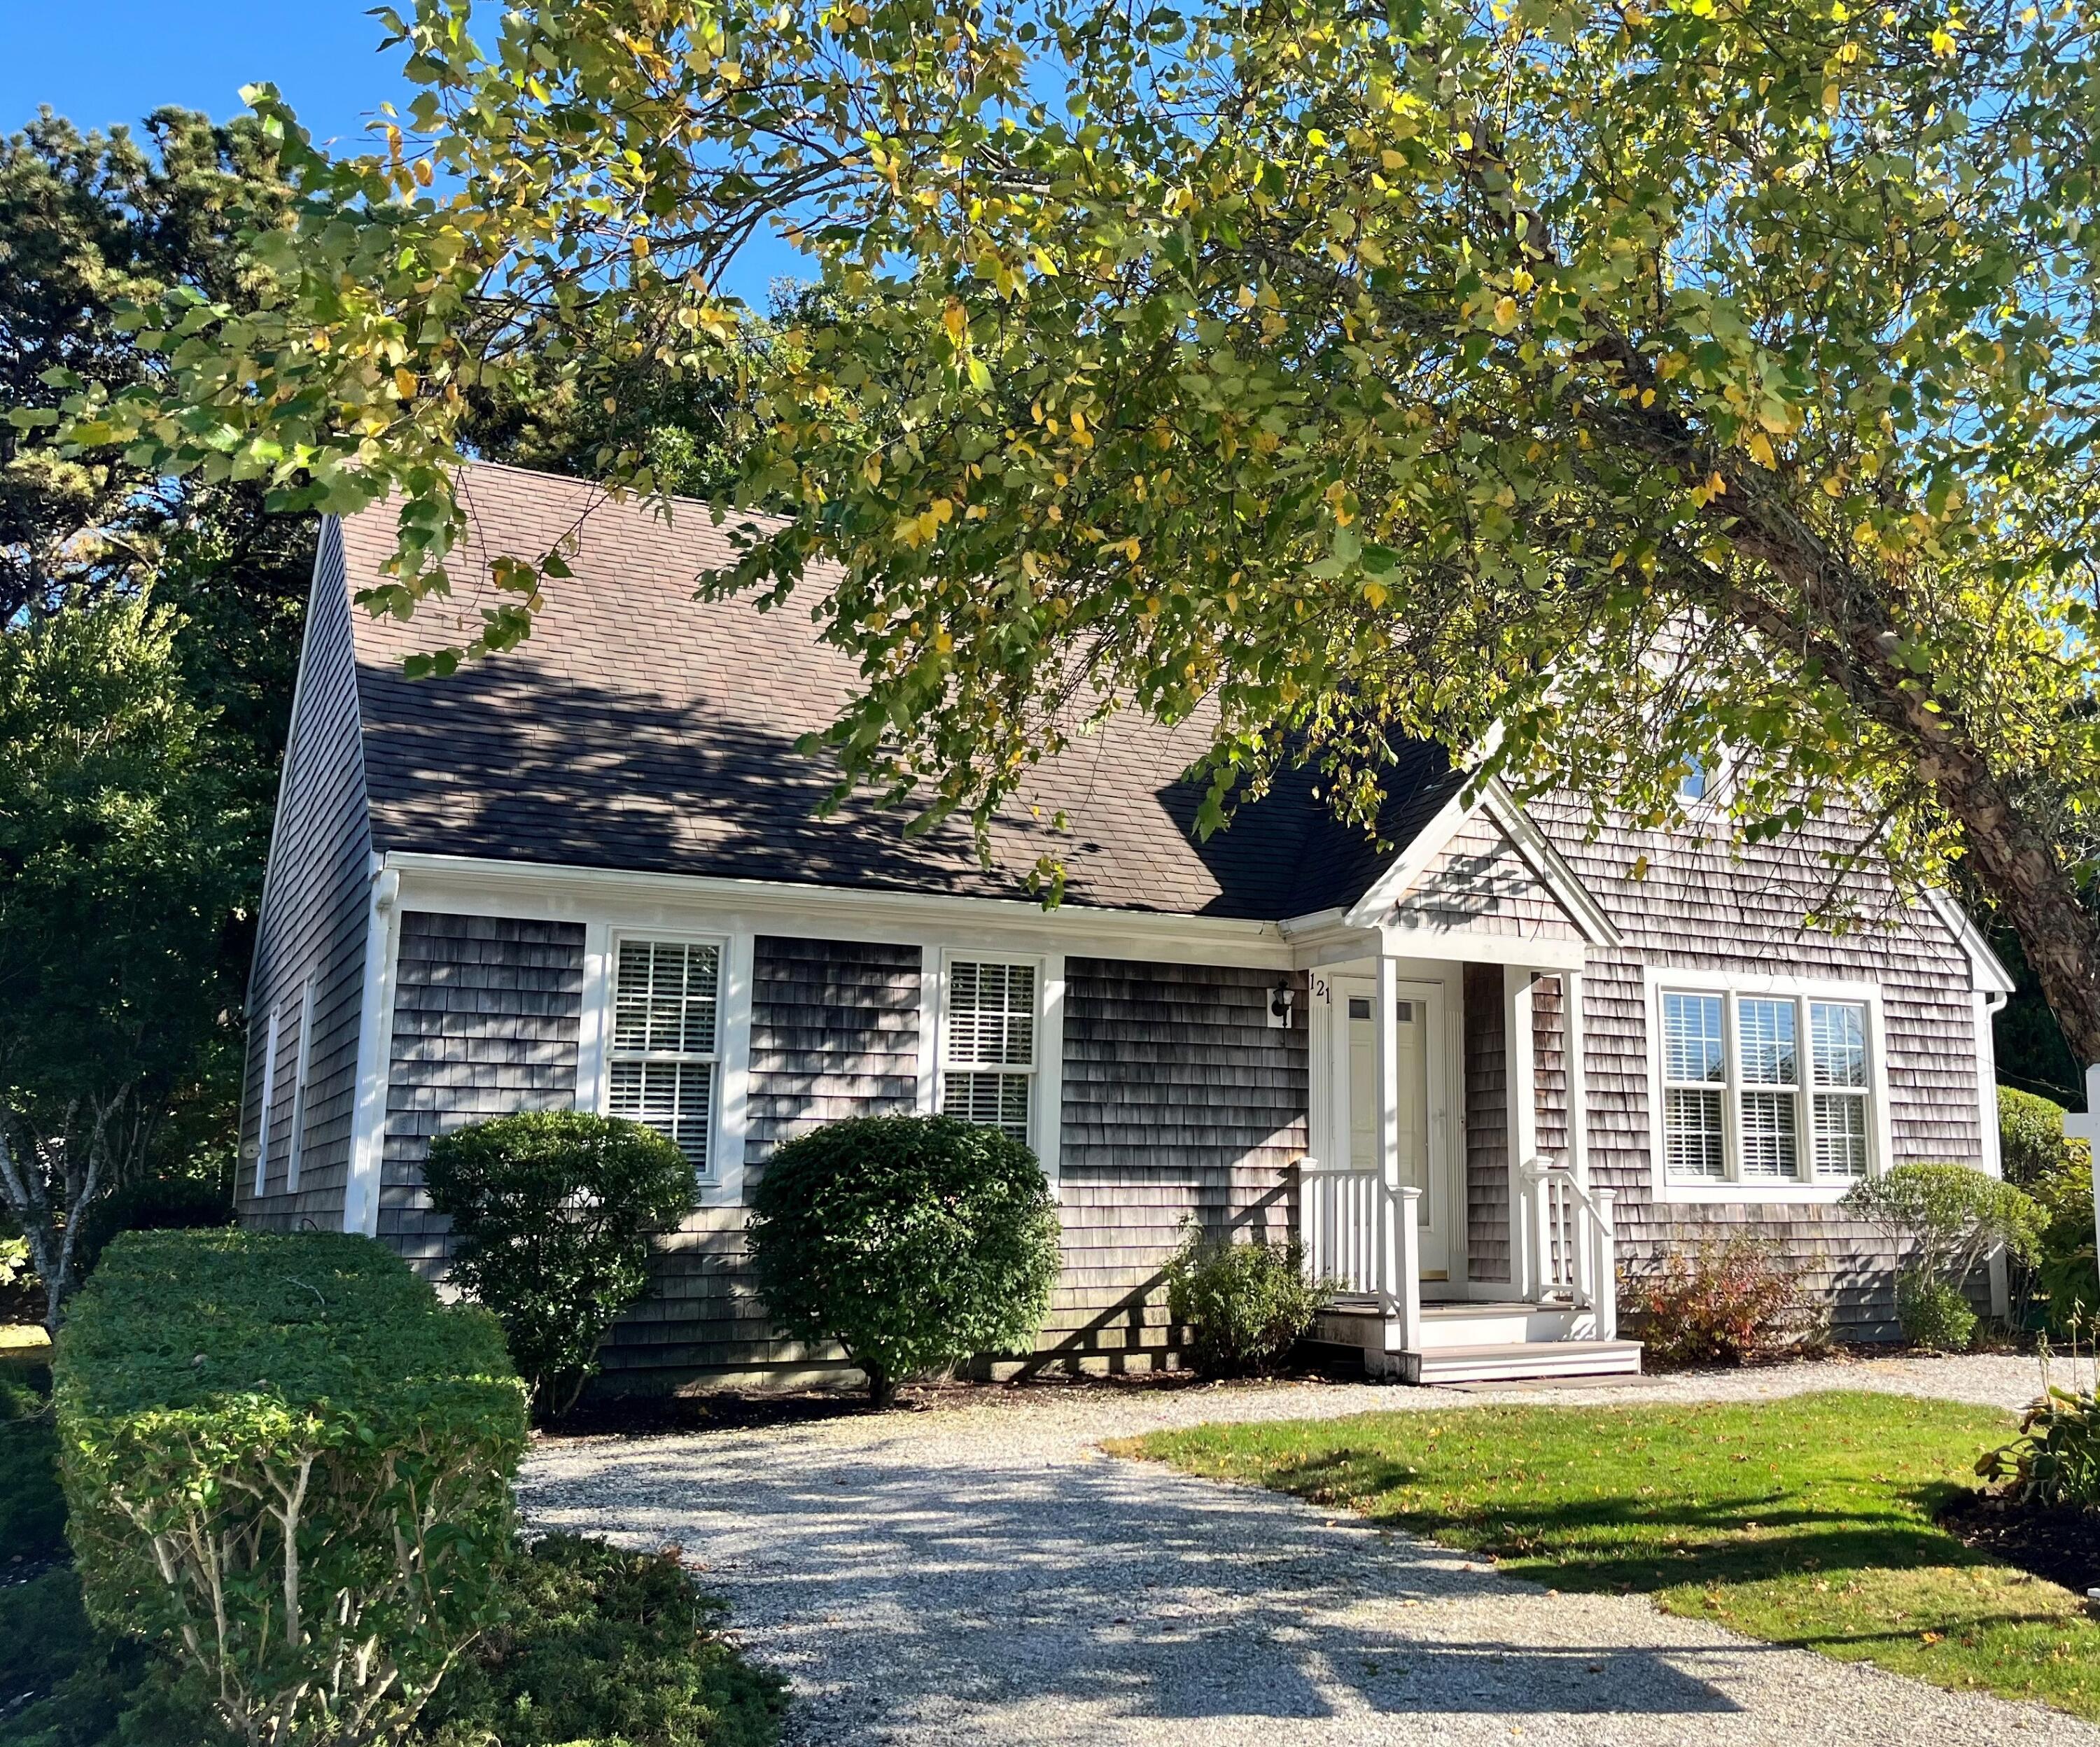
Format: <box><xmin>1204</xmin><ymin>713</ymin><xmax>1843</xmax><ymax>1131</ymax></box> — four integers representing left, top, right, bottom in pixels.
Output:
<box><xmin>1111</xmin><ymin>1392</ymin><xmax>2100</xmax><ymax>1720</ymax></box>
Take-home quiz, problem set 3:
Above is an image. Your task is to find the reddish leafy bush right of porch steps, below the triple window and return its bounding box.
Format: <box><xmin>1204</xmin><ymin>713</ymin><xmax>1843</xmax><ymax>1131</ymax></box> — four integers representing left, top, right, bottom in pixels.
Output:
<box><xmin>1619</xmin><ymin>1237</ymin><xmax>1802</xmax><ymax>1369</ymax></box>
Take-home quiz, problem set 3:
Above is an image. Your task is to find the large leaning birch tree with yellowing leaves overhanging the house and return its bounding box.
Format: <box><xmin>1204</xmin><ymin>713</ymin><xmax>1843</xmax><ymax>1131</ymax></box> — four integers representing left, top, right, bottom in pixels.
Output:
<box><xmin>36</xmin><ymin>0</ymin><xmax>2100</xmax><ymax>1060</ymax></box>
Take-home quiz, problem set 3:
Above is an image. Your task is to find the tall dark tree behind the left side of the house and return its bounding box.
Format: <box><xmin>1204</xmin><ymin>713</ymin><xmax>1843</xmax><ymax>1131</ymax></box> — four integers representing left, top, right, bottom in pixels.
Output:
<box><xmin>0</xmin><ymin>109</ymin><xmax>313</xmax><ymax>1218</ymax></box>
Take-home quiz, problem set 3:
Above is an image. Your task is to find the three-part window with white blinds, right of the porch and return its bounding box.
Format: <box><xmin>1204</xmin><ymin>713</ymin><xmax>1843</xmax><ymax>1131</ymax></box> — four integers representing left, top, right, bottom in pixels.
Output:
<box><xmin>1657</xmin><ymin>985</ymin><xmax>1873</xmax><ymax>1193</ymax></box>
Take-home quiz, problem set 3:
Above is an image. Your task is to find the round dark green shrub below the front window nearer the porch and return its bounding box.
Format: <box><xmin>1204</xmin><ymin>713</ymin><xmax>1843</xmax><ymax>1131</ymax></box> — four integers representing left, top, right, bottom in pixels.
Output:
<box><xmin>750</xmin><ymin>1117</ymin><xmax>1058</xmax><ymax>1407</ymax></box>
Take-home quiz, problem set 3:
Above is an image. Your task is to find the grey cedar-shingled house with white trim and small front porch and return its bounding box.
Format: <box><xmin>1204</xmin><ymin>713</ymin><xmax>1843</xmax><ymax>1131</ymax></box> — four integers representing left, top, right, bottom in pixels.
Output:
<box><xmin>241</xmin><ymin>466</ymin><xmax>2010</xmax><ymax>1386</ymax></box>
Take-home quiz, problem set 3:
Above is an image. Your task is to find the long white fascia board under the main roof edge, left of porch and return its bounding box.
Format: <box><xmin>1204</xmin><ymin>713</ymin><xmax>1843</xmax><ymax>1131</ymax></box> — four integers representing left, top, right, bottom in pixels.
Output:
<box><xmin>386</xmin><ymin>850</ymin><xmax>1292</xmax><ymax>970</ymax></box>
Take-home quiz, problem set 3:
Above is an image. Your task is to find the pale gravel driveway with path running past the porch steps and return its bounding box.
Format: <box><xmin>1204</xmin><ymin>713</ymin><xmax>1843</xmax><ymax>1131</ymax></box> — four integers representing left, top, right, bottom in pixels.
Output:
<box><xmin>523</xmin><ymin>1359</ymin><xmax>2100</xmax><ymax>1747</ymax></box>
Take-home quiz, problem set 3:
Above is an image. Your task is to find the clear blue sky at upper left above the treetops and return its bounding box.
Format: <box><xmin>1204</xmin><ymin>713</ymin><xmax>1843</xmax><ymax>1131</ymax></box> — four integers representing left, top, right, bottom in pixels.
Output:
<box><xmin>0</xmin><ymin>0</ymin><xmax>808</xmax><ymax>304</ymax></box>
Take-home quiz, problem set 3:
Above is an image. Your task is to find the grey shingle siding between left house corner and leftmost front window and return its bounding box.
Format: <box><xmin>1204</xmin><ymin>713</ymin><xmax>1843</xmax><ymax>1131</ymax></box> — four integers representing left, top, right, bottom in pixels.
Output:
<box><xmin>378</xmin><ymin>909</ymin><xmax>584</xmax><ymax>1270</ymax></box>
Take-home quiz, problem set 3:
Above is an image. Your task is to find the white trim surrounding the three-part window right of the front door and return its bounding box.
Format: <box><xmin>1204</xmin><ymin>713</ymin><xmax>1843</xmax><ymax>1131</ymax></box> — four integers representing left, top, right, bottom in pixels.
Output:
<box><xmin>1640</xmin><ymin>964</ymin><xmax>1896</xmax><ymax>1205</ymax></box>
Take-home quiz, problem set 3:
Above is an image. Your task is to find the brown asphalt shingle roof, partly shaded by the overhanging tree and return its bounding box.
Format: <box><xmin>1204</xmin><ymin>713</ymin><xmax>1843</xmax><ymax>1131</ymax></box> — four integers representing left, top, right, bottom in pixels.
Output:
<box><xmin>342</xmin><ymin>466</ymin><xmax>1457</xmax><ymax>920</ymax></box>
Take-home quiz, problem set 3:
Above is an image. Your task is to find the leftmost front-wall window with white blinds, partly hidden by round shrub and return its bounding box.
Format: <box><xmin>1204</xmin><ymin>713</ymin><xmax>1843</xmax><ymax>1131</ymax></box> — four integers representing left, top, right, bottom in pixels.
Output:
<box><xmin>605</xmin><ymin>941</ymin><xmax>722</xmax><ymax>1176</ymax></box>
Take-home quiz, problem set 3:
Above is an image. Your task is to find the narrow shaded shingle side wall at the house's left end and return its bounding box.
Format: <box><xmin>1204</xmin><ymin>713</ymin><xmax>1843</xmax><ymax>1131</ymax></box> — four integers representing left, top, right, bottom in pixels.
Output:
<box><xmin>235</xmin><ymin>523</ymin><xmax>372</xmax><ymax>1230</ymax></box>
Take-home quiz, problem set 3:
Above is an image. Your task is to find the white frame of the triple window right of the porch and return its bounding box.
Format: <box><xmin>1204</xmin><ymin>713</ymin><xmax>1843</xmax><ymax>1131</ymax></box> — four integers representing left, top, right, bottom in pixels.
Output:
<box><xmin>1642</xmin><ymin>966</ymin><xmax>1894</xmax><ymax>1203</ymax></box>
